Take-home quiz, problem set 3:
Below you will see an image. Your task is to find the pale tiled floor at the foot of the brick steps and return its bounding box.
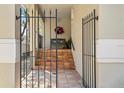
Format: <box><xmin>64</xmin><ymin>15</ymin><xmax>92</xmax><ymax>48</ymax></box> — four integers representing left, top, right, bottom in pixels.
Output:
<box><xmin>22</xmin><ymin>70</ymin><xmax>81</xmax><ymax>88</ymax></box>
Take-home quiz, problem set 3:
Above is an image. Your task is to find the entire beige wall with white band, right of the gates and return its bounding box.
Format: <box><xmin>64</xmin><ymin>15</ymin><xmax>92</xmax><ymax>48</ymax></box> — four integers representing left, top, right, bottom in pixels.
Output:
<box><xmin>97</xmin><ymin>5</ymin><xmax>124</xmax><ymax>87</ymax></box>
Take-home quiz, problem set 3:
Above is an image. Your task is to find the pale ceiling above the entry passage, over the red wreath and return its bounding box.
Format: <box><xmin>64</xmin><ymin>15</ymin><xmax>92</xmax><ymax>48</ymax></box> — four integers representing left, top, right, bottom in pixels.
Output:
<box><xmin>40</xmin><ymin>4</ymin><xmax>72</xmax><ymax>19</ymax></box>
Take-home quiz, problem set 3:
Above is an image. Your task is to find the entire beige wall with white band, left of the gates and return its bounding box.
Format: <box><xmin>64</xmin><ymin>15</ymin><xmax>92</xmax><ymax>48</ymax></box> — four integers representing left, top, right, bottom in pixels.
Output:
<box><xmin>0</xmin><ymin>4</ymin><xmax>16</xmax><ymax>87</ymax></box>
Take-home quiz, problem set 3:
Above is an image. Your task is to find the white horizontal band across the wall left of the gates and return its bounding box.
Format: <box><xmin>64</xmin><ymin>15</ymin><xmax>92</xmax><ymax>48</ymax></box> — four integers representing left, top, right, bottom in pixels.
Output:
<box><xmin>0</xmin><ymin>39</ymin><xmax>16</xmax><ymax>63</ymax></box>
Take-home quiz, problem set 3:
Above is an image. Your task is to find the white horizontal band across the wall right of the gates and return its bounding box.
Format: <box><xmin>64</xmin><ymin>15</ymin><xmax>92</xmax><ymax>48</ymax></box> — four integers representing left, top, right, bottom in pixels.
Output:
<box><xmin>96</xmin><ymin>39</ymin><xmax>124</xmax><ymax>62</ymax></box>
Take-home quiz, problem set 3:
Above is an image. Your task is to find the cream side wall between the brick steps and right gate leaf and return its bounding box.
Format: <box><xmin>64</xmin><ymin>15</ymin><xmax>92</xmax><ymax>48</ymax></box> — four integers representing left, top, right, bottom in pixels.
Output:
<box><xmin>71</xmin><ymin>4</ymin><xmax>98</xmax><ymax>75</ymax></box>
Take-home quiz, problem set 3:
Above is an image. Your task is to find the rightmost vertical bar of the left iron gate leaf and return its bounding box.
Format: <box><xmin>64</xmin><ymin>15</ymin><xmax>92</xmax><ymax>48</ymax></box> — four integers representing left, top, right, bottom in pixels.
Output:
<box><xmin>56</xmin><ymin>9</ymin><xmax>58</xmax><ymax>88</ymax></box>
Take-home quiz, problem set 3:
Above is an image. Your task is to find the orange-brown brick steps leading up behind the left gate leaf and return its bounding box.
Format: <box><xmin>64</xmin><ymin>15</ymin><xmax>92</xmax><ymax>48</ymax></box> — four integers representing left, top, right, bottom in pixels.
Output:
<box><xmin>35</xmin><ymin>49</ymin><xmax>75</xmax><ymax>69</ymax></box>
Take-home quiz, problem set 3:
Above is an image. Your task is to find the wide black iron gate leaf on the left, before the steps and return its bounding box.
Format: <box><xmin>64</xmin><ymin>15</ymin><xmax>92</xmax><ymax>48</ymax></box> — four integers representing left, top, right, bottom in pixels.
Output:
<box><xmin>16</xmin><ymin>9</ymin><xmax>58</xmax><ymax>88</ymax></box>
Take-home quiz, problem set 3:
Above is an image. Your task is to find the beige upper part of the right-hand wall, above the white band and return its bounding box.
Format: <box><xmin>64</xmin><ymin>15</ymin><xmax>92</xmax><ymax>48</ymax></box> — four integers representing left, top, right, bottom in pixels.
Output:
<box><xmin>99</xmin><ymin>4</ymin><xmax>124</xmax><ymax>39</ymax></box>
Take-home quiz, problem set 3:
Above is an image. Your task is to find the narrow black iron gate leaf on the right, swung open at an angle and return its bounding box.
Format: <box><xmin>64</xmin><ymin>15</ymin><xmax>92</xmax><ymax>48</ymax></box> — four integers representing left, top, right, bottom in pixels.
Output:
<box><xmin>82</xmin><ymin>9</ymin><xmax>98</xmax><ymax>88</ymax></box>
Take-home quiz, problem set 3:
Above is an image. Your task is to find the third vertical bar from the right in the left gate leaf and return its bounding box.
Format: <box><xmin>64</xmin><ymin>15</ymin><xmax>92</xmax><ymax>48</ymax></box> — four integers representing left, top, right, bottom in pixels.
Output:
<box><xmin>44</xmin><ymin>10</ymin><xmax>46</xmax><ymax>88</ymax></box>
